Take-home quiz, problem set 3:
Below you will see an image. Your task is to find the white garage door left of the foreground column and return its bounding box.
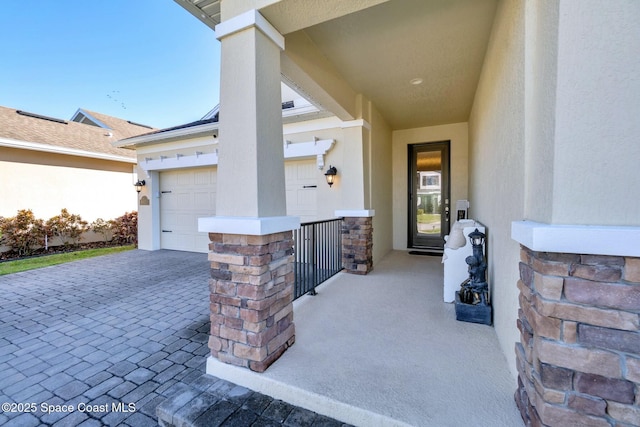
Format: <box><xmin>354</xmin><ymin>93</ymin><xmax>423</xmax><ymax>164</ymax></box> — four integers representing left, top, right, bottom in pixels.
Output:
<box><xmin>160</xmin><ymin>167</ymin><xmax>217</xmax><ymax>252</ymax></box>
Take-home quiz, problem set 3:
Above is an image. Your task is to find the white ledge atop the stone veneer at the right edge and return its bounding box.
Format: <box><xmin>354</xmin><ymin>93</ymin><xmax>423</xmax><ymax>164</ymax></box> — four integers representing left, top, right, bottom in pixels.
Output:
<box><xmin>511</xmin><ymin>220</ymin><xmax>640</xmax><ymax>257</ymax></box>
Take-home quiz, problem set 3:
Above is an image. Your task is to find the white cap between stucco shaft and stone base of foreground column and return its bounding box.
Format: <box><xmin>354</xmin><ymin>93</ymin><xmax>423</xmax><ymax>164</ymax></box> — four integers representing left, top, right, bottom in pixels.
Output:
<box><xmin>198</xmin><ymin>216</ymin><xmax>300</xmax><ymax>236</ymax></box>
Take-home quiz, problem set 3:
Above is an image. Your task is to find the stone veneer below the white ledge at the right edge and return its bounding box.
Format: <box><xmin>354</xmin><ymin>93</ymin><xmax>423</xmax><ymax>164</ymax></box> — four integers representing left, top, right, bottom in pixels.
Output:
<box><xmin>515</xmin><ymin>247</ymin><xmax>640</xmax><ymax>427</ymax></box>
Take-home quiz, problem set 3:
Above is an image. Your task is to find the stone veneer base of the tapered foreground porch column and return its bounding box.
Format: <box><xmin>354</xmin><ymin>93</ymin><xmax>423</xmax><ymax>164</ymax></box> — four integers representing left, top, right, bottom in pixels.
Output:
<box><xmin>209</xmin><ymin>231</ymin><xmax>295</xmax><ymax>372</ymax></box>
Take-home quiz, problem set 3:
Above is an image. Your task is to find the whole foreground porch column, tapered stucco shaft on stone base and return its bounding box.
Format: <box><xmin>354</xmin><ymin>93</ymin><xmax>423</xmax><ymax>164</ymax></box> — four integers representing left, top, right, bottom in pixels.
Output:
<box><xmin>198</xmin><ymin>10</ymin><xmax>300</xmax><ymax>375</ymax></box>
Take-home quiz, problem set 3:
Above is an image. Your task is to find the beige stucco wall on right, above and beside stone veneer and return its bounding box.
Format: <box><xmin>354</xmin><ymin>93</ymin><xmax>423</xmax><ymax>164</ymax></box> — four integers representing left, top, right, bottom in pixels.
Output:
<box><xmin>469</xmin><ymin>0</ymin><xmax>640</xmax><ymax>384</ymax></box>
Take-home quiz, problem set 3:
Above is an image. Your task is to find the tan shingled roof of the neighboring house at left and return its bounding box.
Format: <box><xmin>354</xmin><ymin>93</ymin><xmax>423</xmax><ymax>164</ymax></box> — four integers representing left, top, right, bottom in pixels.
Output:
<box><xmin>0</xmin><ymin>107</ymin><xmax>155</xmax><ymax>162</ymax></box>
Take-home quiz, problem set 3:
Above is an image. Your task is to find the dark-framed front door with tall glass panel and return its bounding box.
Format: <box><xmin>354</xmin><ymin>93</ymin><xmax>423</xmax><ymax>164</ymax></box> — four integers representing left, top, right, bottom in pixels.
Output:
<box><xmin>408</xmin><ymin>141</ymin><xmax>450</xmax><ymax>251</ymax></box>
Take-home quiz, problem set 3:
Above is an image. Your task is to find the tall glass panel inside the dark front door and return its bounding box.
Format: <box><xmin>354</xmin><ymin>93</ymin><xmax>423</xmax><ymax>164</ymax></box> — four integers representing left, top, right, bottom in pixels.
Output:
<box><xmin>415</xmin><ymin>151</ymin><xmax>442</xmax><ymax>236</ymax></box>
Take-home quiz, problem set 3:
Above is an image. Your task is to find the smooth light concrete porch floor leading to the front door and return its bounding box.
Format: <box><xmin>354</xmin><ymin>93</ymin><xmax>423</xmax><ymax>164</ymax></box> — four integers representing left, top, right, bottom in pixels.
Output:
<box><xmin>207</xmin><ymin>251</ymin><xmax>523</xmax><ymax>427</ymax></box>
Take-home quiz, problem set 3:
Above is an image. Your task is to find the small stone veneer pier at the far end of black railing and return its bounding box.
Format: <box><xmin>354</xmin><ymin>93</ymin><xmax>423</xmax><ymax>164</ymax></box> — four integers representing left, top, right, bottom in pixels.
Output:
<box><xmin>342</xmin><ymin>217</ymin><xmax>373</xmax><ymax>274</ymax></box>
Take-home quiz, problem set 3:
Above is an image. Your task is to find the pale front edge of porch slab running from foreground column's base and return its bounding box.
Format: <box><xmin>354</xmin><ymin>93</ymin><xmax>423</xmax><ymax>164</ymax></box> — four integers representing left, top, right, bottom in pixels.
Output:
<box><xmin>207</xmin><ymin>356</ymin><xmax>411</xmax><ymax>427</ymax></box>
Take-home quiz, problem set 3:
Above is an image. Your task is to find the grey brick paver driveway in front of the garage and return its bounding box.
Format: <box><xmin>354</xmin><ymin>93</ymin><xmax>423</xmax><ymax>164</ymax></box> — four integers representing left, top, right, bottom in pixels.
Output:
<box><xmin>0</xmin><ymin>250</ymin><xmax>209</xmax><ymax>427</ymax></box>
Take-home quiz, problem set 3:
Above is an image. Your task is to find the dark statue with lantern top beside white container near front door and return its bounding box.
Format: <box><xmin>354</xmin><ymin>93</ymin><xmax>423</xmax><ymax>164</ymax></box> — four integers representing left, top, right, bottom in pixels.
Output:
<box><xmin>460</xmin><ymin>228</ymin><xmax>489</xmax><ymax>305</ymax></box>
